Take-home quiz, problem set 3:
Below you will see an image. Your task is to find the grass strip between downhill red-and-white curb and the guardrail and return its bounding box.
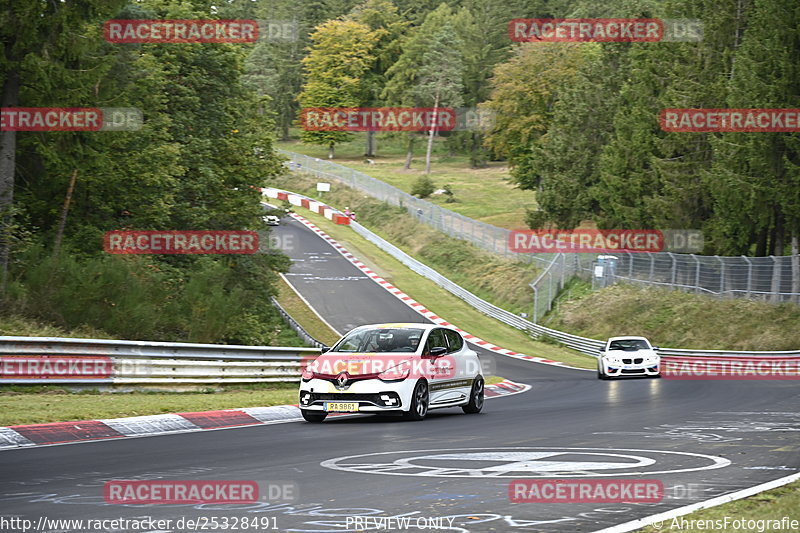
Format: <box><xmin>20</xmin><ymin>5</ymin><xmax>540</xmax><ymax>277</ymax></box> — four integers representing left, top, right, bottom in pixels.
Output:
<box><xmin>288</xmin><ymin>202</ymin><xmax>595</xmax><ymax>368</ymax></box>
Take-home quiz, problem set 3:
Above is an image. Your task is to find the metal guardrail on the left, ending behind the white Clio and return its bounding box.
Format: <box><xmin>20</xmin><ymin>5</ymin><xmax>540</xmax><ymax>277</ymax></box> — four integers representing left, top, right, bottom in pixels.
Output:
<box><xmin>0</xmin><ymin>336</ymin><xmax>320</xmax><ymax>385</ymax></box>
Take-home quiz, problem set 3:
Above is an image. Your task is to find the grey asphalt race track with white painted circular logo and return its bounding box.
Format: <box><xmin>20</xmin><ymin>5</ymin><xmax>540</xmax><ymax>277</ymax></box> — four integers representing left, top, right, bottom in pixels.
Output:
<box><xmin>0</xmin><ymin>214</ymin><xmax>800</xmax><ymax>532</ymax></box>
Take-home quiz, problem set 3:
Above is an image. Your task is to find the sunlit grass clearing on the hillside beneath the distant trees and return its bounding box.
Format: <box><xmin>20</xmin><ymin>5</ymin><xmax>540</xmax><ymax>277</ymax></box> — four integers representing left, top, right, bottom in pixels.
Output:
<box><xmin>276</xmin><ymin>133</ymin><xmax>536</xmax><ymax>229</ymax></box>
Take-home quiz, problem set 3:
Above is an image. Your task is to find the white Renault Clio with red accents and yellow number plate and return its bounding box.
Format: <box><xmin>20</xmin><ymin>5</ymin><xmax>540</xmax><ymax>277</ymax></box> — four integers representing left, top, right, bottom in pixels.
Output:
<box><xmin>300</xmin><ymin>323</ymin><xmax>484</xmax><ymax>422</ymax></box>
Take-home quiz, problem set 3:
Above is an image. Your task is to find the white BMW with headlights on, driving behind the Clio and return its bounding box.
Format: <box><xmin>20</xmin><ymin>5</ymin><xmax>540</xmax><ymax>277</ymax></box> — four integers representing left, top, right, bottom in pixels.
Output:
<box><xmin>597</xmin><ymin>337</ymin><xmax>661</xmax><ymax>379</ymax></box>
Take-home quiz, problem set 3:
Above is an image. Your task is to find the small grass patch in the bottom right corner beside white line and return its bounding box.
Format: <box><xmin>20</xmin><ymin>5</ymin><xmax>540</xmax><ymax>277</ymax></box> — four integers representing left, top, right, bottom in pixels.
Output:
<box><xmin>639</xmin><ymin>482</ymin><xmax>800</xmax><ymax>533</ymax></box>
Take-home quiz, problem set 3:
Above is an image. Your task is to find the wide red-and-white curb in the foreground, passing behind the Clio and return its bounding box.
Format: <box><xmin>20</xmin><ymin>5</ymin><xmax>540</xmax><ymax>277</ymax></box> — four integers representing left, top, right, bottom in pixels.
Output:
<box><xmin>0</xmin><ymin>380</ymin><xmax>531</xmax><ymax>451</ymax></box>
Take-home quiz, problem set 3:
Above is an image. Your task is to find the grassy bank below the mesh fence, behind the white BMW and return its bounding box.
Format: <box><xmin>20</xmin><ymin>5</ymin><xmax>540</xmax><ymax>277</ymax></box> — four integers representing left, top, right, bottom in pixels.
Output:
<box><xmin>544</xmin><ymin>282</ymin><xmax>800</xmax><ymax>350</ymax></box>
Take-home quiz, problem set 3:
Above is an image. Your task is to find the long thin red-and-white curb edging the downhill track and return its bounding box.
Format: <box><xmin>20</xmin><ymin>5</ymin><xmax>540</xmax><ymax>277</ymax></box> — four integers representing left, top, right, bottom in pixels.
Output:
<box><xmin>289</xmin><ymin>208</ymin><xmax>587</xmax><ymax>370</ymax></box>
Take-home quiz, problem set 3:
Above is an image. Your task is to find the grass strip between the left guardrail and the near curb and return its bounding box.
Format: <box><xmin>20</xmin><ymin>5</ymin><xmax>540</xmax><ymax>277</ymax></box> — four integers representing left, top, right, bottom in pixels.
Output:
<box><xmin>0</xmin><ymin>383</ymin><xmax>298</xmax><ymax>426</ymax></box>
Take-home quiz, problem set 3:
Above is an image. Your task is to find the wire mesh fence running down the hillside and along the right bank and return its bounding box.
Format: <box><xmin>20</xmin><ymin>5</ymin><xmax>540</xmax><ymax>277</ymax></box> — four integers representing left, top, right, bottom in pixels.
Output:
<box><xmin>278</xmin><ymin>150</ymin><xmax>800</xmax><ymax>322</ymax></box>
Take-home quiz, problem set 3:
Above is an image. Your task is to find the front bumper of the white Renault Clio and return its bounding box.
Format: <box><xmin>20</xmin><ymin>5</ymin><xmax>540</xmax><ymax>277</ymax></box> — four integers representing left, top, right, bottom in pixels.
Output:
<box><xmin>299</xmin><ymin>378</ymin><xmax>414</xmax><ymax>413</ymax></box>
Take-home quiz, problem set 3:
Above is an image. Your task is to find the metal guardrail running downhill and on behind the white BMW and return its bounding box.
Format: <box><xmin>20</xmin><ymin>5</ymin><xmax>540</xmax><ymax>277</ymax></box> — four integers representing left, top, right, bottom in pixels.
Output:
<box><xmin>266</xmin><ymin>189</ymin><xmax>800</xmax><ymax>357</ymax></box>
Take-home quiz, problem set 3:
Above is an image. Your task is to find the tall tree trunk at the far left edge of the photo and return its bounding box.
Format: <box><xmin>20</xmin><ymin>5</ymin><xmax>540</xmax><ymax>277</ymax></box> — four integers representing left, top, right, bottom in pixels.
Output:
<box><xmin>0</xmin><ymin>58</ymin><xmax>19</xmax><ymax>296</ymax></box>
